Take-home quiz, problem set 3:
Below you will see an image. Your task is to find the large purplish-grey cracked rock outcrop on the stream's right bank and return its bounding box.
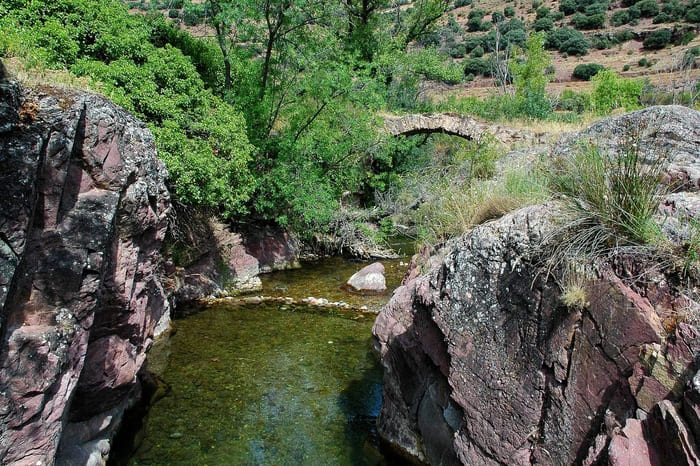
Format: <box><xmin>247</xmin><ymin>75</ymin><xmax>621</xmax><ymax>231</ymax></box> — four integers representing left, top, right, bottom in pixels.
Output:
<box><xmin>373</xmin><ymin>108</ymin><xmax>700</xmax><ymax>465</ymax></box>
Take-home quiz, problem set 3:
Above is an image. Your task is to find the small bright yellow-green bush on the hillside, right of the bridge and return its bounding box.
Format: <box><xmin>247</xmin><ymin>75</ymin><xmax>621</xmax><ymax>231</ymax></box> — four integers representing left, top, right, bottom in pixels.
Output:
<box><xmin>591</xmin><ymin>70</ymin><xmax>644</xmax><ymax>115</ymax></box>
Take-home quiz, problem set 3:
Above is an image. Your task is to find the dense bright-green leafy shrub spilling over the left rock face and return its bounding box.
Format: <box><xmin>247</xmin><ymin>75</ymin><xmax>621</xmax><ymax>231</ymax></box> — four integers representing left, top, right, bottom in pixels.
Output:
<box><xmin>4</xmin><ymin>0</ymin><xmax>253</xmax><ymax>215</ymax></box>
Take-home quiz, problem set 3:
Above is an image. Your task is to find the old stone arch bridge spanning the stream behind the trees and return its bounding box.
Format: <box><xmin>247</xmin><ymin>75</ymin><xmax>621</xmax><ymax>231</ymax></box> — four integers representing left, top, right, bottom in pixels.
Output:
<box><xmin>385</xmin><ymin>113</ymin><xmax>545</xmax><ymax>145</ymax></box>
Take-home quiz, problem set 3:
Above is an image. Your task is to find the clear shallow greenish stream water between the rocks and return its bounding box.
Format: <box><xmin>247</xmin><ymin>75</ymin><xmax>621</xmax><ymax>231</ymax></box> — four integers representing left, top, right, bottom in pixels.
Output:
<box><xmin>128</xmin><ymin>258</ymin><xmax>406</xmax><ymax>465</ymax></box>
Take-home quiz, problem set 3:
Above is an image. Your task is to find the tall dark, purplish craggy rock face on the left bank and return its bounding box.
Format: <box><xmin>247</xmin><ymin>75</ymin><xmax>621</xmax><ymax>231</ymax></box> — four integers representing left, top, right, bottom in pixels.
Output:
<box><xmin>0</xmin><ymin>78</ymin><xmax>170</xmax><ymax>464</ymax></box>
